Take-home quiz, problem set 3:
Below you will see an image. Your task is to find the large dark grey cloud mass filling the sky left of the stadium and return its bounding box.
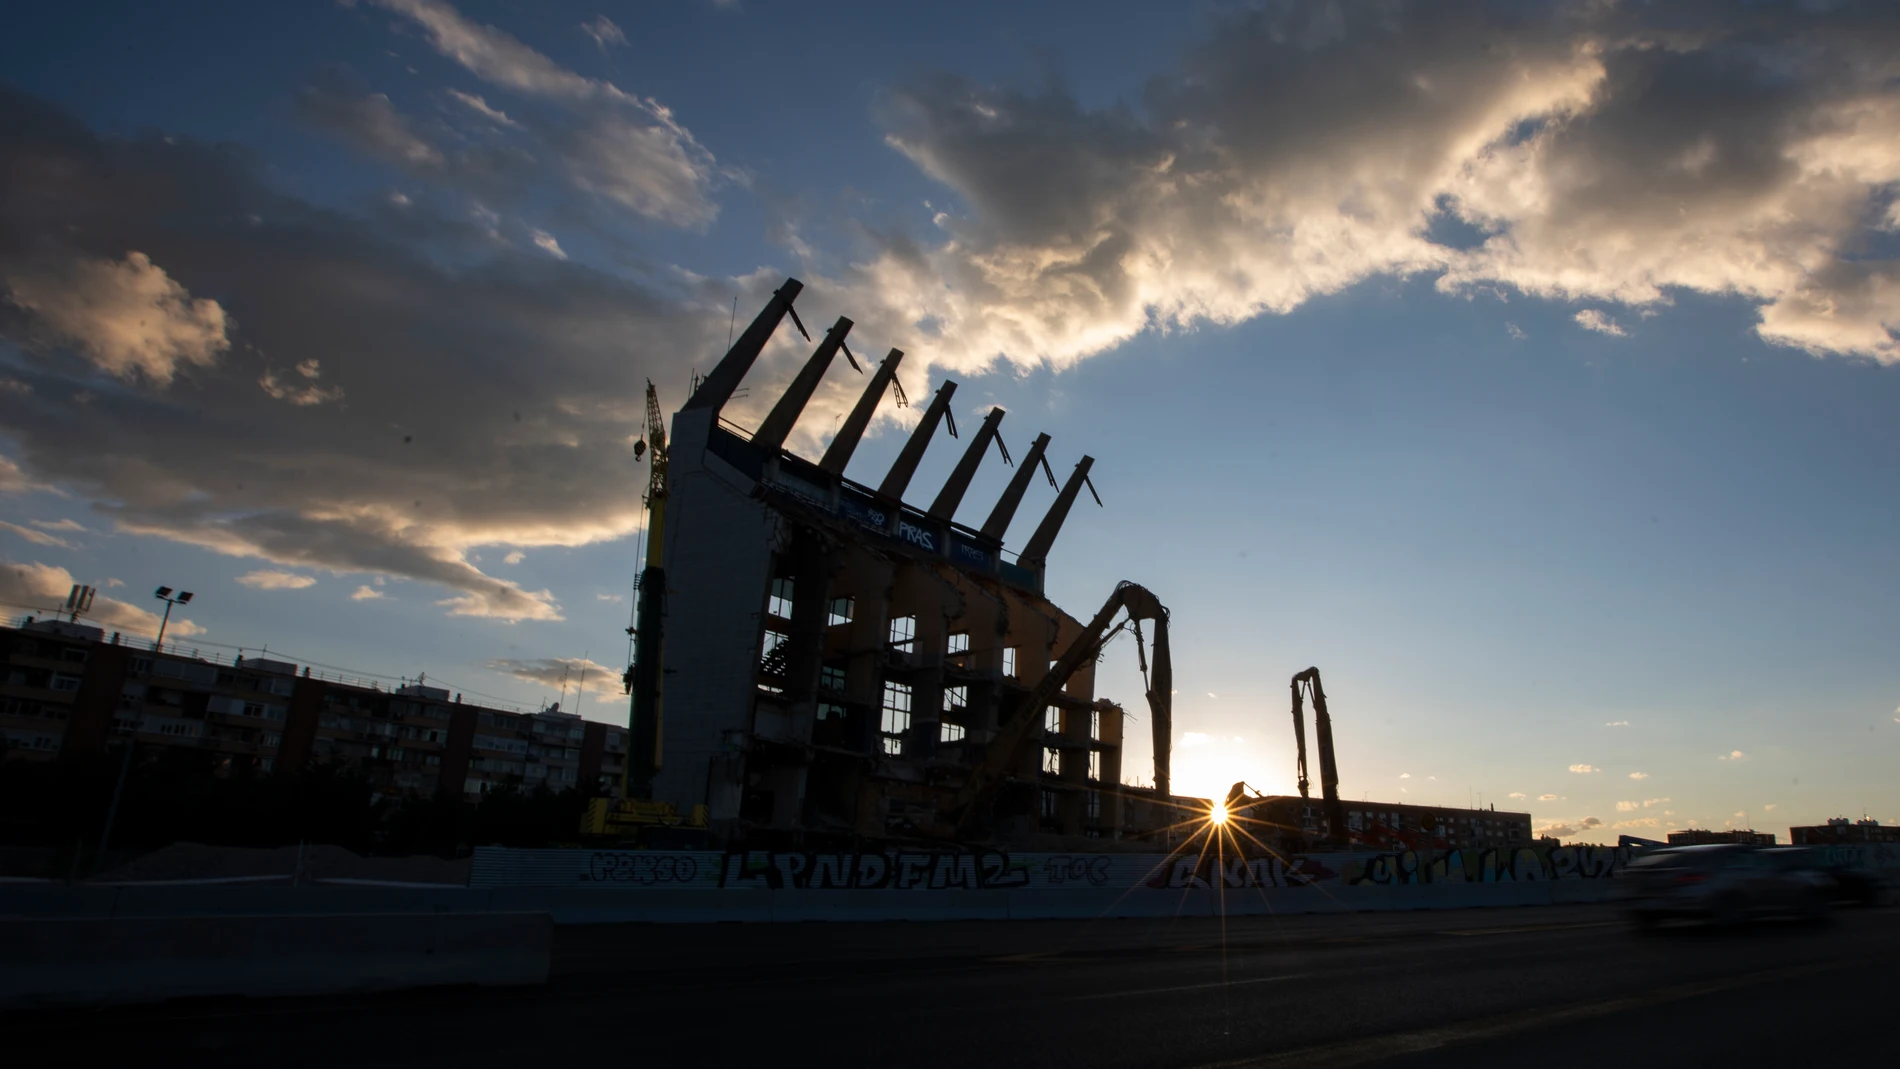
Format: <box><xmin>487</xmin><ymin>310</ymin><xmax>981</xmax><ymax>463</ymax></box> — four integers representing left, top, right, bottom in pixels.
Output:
<box><xmin>0</xmin><ymin>89</ymin><xmax>771</xmax><ymax>621</ymax></box>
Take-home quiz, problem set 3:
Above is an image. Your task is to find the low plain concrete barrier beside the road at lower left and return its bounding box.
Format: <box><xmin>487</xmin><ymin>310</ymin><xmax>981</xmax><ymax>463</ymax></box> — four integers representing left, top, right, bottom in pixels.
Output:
<box><xmin>0</xmin><ymin>911</ymin><xmax>553</xmax><ymax>1008</ymax></box>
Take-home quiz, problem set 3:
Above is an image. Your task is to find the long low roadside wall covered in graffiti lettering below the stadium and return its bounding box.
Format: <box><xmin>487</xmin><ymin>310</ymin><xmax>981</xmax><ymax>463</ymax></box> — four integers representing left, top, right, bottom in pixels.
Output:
<box><xmin>469</xmin><ymin>847</ymin><xmax>1634</xmax><ymax>892</ymax></box>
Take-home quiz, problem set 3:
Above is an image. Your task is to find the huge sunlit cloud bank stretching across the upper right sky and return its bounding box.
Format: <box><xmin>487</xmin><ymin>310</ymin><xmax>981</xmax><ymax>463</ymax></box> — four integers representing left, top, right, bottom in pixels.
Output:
<box><xmin>853</xmin><ymin>0</ymin><xmax>1900</xmax><ymax>368</ymax></box>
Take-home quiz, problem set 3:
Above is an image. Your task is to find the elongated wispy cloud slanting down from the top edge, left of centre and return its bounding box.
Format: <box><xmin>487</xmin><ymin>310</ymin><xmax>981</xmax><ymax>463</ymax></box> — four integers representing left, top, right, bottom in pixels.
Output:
<box><xmin>372</xmin><ymin>0</ymin><xmax>718</xmax><ymax>226</ymax></box>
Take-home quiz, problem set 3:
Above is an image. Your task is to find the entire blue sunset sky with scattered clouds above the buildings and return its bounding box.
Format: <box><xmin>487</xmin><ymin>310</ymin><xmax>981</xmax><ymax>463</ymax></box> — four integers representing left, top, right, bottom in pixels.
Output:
<box><xmin>0</xmin><ymin>0</ymin><xmax>1900</xmax><ymax>841</ymax></box>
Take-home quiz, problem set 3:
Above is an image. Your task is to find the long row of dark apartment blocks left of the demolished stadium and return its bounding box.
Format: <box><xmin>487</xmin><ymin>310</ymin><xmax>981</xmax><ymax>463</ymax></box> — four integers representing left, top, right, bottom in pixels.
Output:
<box><xmin>0</xmin><ymin>617</ymin><xmax>627</xmax><ymax>799</ymax></box>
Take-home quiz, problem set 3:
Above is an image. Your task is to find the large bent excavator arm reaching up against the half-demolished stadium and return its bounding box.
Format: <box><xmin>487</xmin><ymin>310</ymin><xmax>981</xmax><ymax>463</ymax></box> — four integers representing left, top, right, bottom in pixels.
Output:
<box><xmin>944</xmin><ymin>581</ymin><xmax>1174</xmax><ymax>837</ymax></box>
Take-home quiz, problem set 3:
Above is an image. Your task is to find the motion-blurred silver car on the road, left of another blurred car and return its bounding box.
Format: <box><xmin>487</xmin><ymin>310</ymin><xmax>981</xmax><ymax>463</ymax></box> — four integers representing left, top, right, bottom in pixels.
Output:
<box><xmin>1623</xmin><ymin>843</ymin><xmax>1837</xmax><ymax>928</ymax></box>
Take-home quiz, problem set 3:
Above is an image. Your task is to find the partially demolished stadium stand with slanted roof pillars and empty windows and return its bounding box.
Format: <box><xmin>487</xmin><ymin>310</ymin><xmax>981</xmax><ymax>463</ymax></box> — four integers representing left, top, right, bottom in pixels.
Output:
<box><xmin>629</xmin><ymin>279</ymin><xmax>1172</xmax><ymax>841</ymax></box>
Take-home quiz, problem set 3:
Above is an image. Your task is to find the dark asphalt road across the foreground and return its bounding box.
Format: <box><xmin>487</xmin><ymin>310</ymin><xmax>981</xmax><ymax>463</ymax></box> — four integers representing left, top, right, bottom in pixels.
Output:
<box><xmin>0</xmin><ymin>908</ymin><xmax>1900</xmax><ymax>1069</ymax></box>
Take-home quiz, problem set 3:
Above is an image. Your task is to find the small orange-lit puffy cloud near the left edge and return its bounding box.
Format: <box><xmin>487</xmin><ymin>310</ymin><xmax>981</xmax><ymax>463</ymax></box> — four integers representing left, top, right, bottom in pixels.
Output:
<box><xmin>0</xmin><ymin>251</ymin><xmax>230</xmax><ymax>385</ymax></box>
